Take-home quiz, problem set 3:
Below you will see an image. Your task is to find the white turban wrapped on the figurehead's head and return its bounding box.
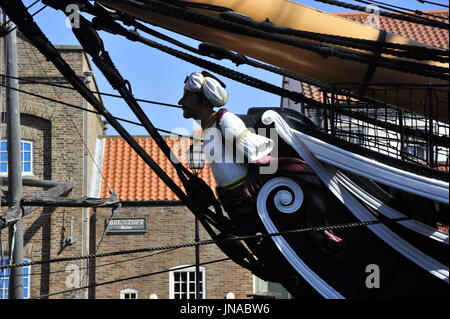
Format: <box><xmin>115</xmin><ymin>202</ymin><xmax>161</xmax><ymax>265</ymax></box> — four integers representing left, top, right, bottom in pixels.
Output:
<box><xmin>184</xmin><ymin>72</ymin><xmax>228</xmax><ymax>106</ymax></box>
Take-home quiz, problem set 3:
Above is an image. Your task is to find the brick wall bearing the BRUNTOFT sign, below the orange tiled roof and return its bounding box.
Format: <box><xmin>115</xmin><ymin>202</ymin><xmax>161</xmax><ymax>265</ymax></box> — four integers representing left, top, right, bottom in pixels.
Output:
<box><xmin>91</xmin><ymin>205</ymin><xmax>253</xmax><ymax>299</ymax></box>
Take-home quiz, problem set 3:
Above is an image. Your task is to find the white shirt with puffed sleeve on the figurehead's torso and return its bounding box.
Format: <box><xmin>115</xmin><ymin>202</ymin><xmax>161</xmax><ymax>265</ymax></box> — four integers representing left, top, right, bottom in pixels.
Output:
<box><xmin>203</xmin><ymin>112</ymin><xmax>274</xmax><ymax>187</ymax></box>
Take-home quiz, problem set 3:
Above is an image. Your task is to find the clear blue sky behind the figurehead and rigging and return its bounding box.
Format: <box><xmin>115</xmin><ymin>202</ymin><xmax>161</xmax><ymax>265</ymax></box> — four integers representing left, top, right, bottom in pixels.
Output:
<box><xmin>14</xmin><ymin>0</ymin><xmax>448</xmax><ymax>135</ymax></box>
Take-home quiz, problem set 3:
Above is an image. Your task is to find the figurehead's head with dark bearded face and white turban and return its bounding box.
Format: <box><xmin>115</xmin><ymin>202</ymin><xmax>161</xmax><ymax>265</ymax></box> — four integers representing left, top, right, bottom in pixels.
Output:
<box><xmin>178</xmin><ymin>71</ymin><xmax>228</xmax><ymax>120</ymax></box>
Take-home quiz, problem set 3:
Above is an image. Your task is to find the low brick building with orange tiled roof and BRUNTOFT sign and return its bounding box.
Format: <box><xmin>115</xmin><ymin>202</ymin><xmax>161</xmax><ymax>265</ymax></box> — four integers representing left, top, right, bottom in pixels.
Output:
<box><xmin>91</xmin><ymin>137</ymin><xmax>254</xmax><ymax>299</ymax></box>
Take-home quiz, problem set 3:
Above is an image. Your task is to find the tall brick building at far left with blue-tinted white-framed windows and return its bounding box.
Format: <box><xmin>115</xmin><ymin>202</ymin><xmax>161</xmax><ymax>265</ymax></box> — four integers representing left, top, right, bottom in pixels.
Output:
<box><xmin>0</xmin><ymin>33</ymin><xmax>104</xmax><ymax>298</ymax></box>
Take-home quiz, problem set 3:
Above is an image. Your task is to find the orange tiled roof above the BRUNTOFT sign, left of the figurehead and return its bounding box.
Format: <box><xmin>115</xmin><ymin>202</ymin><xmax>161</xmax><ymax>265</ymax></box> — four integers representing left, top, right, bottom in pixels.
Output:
<box><xmin>100</xmin><ymin>137</ymin><xmax>216</xmax><ymax>201</ymax></box>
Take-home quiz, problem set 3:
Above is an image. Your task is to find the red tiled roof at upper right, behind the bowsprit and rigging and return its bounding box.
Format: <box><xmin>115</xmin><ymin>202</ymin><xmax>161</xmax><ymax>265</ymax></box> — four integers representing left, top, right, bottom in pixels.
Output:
<box><xmin>302</xmin><ymin>10</ymin><xmax>449</xmax><ymax>101</ymax></box>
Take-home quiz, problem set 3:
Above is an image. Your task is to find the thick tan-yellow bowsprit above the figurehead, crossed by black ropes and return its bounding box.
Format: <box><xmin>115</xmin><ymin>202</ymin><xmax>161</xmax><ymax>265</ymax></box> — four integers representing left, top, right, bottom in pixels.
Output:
<box><xmin>97</xmin><ymin>0</ymin><xmax>448</xmax><ymax>123</ymax></box>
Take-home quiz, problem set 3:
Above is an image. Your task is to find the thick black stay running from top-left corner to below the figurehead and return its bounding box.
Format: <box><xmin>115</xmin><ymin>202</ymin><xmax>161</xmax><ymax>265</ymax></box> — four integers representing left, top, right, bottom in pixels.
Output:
<box><xmin>0</xmin><ymin>0</ymin><xmax>267</xmax><ymax>278</ymax></box>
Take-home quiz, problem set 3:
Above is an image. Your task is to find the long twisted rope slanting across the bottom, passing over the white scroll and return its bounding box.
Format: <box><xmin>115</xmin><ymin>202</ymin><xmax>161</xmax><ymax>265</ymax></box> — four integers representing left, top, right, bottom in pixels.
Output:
<box><xmin>0</xmin><ymin>216</ymin><xmax>414</xmax><ymax>269</ymax></box>
